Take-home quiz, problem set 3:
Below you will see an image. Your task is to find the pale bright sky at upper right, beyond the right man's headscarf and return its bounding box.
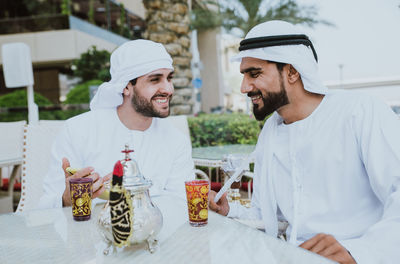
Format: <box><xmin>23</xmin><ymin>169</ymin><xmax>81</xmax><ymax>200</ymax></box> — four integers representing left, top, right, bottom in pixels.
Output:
<box><xmin>298</xmin><ymin>0</ymin><xmax>400</xmax><ymax>82</ymax></box>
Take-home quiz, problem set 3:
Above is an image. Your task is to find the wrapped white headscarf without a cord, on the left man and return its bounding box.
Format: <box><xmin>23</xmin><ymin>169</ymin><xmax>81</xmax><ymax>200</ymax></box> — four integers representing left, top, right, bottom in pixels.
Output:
<box><xmin>90</xmin><ymin>39</ymin><xmax>174</xmax><ymax>110</ymax></box>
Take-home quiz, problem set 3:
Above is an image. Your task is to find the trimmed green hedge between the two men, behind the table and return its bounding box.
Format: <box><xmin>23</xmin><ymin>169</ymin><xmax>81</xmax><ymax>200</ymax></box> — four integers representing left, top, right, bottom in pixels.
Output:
<box><xmin>188</xmin><ymin>113</ymin><xmax>260</xmax><ymax>148</ymax></box>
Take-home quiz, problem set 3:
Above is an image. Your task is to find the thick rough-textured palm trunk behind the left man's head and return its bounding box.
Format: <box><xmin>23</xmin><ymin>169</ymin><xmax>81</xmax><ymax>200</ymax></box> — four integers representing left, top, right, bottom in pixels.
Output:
<box><xmin>143</xmin><ymin>0</ymin><xmax>193</xmax><ymax>115</ymax></box>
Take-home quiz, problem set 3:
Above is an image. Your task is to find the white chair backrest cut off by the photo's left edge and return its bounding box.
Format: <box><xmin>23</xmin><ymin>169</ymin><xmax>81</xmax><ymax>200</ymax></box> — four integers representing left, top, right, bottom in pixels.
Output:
<box><xmin>0</xmin><ymin>120</ymin><xmax>26</xmax><ymax>160</ymax></box>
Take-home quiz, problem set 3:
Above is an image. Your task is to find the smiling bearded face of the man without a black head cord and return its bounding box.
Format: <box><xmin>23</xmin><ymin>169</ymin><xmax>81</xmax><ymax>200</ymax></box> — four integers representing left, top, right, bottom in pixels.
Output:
<box><xmin>128</xmin><ymin>69</ymin><xmax>174</xmax><ymax>118</ymax></box>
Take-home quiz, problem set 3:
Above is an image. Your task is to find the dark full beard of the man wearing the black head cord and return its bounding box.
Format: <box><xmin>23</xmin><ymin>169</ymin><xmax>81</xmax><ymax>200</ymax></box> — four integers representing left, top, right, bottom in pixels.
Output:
<box><xmin>247</xmin><ymin>81</ymin><xmax>289</xmax><ymax>121</ymax></box>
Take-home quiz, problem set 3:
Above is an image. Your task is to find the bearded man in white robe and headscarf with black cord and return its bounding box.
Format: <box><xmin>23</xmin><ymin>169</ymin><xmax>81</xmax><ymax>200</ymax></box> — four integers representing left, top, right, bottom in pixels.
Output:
<box><xmin>210</xmin><ymin>21</ymin><xmax>400</xmax><ymax>264</ymax></box>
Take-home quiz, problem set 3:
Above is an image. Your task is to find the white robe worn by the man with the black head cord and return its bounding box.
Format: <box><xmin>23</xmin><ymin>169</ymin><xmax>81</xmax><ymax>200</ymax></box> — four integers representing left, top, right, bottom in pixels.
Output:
<box><xmin>228</xmin><ymin>92</ymin><xmax>400</xmax><ymax>264</ymax></box>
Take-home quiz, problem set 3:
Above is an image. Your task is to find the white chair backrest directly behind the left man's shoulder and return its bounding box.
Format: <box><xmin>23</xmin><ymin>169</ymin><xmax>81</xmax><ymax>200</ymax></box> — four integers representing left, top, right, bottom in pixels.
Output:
<box><xmin>17</xmin><ymin>120</ymin><xmax>65</xmax><ymax>212</ymax></box>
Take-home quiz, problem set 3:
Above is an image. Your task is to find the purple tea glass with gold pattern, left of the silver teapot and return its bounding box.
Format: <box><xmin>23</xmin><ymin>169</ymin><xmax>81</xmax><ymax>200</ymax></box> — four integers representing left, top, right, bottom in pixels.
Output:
<box><xmin>69</xmin><ymin>178</ymin><xmax>93</xmax><ymax>221</ymax></box>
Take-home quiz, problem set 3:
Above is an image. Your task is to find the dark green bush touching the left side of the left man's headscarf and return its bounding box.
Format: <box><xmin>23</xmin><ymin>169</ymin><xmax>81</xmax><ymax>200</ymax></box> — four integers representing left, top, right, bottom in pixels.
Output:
<box><xmin>72</xmin><ymin>46</ymin><xmax>111</xmax><ymax>83</ymax></box>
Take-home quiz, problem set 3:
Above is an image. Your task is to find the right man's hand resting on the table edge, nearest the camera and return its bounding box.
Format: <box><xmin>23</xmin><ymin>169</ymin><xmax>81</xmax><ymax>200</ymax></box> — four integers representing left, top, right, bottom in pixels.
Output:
<box><xmin>299</xmin><ymin>233</ymin><xmax>356</xmax><ymax>264</ymax></box>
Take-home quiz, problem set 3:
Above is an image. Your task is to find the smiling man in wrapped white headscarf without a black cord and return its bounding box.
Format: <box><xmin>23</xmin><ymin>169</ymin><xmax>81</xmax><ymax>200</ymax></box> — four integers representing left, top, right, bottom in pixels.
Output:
<box><xmin>40</xmin><ymin>40</ymin><xmax>194</xmax><ymax>207</ymax></box>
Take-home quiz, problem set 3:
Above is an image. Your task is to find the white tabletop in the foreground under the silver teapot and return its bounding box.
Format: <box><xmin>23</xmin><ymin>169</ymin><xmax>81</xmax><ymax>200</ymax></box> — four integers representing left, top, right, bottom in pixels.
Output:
<box><xmin>0</xmin><ymin>196</ymin><xmax>333</xmax><ymax>264</ymax></box>
